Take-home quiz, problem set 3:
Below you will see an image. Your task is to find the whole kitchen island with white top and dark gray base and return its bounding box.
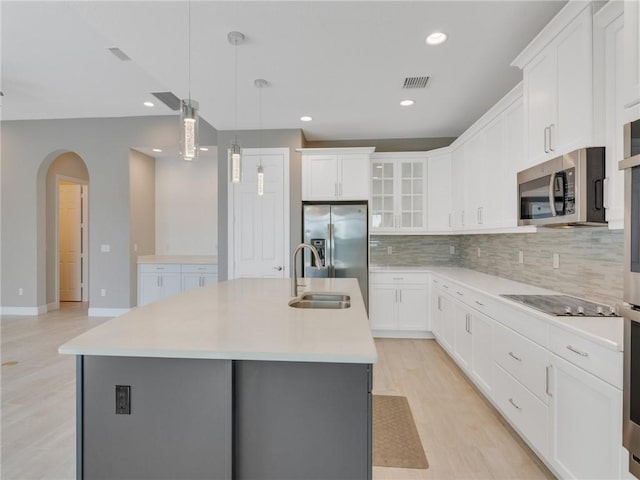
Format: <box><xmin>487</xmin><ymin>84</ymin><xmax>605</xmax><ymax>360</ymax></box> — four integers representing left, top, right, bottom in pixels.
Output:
<box><xmin>59</xmin><ymin>278</ymin><xmax>377</xmax><ymax>479</ymax></box>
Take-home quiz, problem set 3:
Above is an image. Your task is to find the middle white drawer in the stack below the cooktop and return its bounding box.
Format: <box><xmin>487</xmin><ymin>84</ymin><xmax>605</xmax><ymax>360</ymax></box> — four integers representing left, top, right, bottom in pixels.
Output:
<box><xmin>493</xmin><ymin>324</ymin><xmax>549</xmax><ymax>403</ymax></box>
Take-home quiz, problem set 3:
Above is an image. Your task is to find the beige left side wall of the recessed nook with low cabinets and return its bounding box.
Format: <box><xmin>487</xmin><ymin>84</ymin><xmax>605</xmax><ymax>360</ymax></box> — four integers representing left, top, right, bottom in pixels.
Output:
<box><xmin>129</xmin><ymin>150</ymin><xmax>156</xmax><ymax>305</ymax></box>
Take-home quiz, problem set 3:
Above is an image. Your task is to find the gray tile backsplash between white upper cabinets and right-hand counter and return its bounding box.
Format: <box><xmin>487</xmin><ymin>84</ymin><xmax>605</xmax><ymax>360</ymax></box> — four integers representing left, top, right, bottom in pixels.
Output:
<box><xmin>370</xmin><ymin>227</ymin><xmax>623</xmax><ymax>305</ymax></box>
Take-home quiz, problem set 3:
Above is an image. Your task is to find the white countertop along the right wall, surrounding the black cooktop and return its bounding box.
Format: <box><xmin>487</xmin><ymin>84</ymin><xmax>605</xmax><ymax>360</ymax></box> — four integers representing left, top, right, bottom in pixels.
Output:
<box><xmin>370</xmin><ymin>266</ymin><xmax>624</xmax><ymax>352</ymax></box>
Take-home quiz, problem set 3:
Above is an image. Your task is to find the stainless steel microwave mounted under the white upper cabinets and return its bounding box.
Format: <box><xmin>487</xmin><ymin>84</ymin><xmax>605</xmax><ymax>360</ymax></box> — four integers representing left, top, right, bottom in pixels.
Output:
<box><xmin>518</xmin><ymin>147</ymin><xmax>607</xmax><ymax>227</ymax></box>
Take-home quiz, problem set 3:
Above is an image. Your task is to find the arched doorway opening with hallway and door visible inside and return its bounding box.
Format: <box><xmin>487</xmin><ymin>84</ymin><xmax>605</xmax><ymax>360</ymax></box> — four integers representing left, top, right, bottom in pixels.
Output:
<box><xmin>45</xmin><ymin>152</ymin><xmax>89</xmax><ymax>310</ymax></box>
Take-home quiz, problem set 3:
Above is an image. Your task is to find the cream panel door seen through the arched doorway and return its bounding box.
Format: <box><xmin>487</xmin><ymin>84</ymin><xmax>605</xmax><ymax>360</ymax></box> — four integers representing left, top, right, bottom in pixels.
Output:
<box><xmin>58</xmin><ymin>184</ymin><xmax>82</xmax><ymax>302</ymax></box>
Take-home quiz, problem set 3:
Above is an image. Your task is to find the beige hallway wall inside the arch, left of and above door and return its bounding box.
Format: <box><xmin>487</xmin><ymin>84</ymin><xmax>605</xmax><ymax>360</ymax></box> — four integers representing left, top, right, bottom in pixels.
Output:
<box><xmin>45</xmin><ymin>152</ymin><xmax>89</xmax><ymax>303</ymax></box>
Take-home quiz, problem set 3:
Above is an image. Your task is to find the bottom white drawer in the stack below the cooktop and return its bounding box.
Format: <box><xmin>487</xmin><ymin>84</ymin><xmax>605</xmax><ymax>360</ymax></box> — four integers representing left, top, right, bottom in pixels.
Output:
<box><xmin>493</xmin><ymin>363</ymin><xmax>548</xmax><ymax>457</ymax></box>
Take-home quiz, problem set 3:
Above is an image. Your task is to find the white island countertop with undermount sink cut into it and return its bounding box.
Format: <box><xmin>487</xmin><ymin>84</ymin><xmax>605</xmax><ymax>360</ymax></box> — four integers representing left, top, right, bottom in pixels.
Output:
<box><xmin>59</xmin><ymin>278</ymin><xmax>377</xmax><ymax>363</ymax></box>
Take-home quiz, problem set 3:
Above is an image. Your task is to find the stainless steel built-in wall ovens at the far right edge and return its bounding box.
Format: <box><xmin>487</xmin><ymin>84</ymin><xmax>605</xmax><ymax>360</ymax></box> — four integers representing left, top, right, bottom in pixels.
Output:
<box><xmin>619</xmin><ymin>119</ymin><xmax>640</xmax><ymax>478</ymax></box>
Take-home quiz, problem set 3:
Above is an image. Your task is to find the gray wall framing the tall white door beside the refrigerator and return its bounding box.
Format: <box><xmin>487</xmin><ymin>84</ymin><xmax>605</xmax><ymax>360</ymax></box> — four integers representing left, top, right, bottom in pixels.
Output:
<box><xmin>218</xmin><ymin>129</ymin><xmax>303</xmax><ymax>280</ymax></box>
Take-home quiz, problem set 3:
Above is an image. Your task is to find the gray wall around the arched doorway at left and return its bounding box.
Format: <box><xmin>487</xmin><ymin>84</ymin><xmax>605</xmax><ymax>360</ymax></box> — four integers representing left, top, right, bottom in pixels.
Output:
<box><xmin>0</xmin><ymin>116</ymin><xmax>217</xmax><ymax>308</ymax></box>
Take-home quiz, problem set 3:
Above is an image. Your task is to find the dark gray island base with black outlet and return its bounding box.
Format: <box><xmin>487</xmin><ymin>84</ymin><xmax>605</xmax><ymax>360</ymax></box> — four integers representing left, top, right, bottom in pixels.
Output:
<box><xmin>77</xmin><ymin>356</ymin><xmax>372</xmax><ymax>480</ymax></box>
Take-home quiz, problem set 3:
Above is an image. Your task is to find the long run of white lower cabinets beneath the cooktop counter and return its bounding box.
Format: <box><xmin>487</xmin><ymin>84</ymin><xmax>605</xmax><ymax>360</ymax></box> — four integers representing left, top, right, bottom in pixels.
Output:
<box><xmin>430</xmin><ymin>275</ymin><xmax>629</xmax><ymax>480</ymax></box>
